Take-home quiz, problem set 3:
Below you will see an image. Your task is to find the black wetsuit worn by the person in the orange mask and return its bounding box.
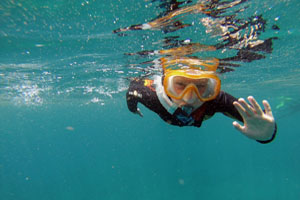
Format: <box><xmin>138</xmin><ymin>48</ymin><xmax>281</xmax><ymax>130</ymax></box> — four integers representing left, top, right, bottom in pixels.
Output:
<box><xmin>126</xmin><ymin>79</ymin><xmax>277</xmax><ymax>143</ymax></box>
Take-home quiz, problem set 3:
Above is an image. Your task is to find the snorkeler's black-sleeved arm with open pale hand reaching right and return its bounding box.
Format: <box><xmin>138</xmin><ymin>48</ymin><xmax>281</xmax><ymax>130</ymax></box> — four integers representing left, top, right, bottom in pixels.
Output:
<box><xmin>214</xmin><ymin>92</ymin><xmax>277</xmax><ymax>143</ymax></box>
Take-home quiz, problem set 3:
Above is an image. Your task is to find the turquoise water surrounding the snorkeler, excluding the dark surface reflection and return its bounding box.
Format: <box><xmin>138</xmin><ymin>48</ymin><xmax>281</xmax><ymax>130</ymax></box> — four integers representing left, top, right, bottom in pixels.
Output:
<box><xmin>0</xmin><ymin>0</ymin><xmax>300</xmax><ymax>200</ymax></box>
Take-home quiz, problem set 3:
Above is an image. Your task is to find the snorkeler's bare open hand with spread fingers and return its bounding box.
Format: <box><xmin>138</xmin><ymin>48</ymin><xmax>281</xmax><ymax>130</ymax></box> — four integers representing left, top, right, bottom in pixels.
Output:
<box><xmin>233</xmin><ymin>96</ymin><xmax>275</xmax><ymax>141</ymax></box>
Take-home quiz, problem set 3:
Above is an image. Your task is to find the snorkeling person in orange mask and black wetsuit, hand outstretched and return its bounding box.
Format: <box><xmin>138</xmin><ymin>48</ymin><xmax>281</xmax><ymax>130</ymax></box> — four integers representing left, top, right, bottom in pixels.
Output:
<box><xmin>126</xmin><ymin>66</ymin><xmax>277</xmax><ymax>143</ymax></box>
